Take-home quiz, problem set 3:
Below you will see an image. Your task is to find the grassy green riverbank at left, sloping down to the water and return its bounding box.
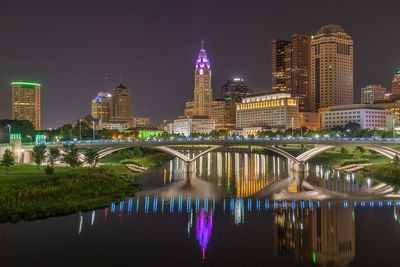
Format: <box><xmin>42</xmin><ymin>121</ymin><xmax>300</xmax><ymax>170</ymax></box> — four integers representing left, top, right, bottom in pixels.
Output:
<box><xmin>0</xmin><ymin>165</ymin><xmax>141</xmax><ymax>222</ymax></box>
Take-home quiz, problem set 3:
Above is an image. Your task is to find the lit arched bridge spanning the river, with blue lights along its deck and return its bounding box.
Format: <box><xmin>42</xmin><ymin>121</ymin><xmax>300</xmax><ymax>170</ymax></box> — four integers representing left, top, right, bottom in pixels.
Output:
<box><xmin>0</xmin><ymin>137</ymin><xmax>400</xmax><ymax>172</ymax></box>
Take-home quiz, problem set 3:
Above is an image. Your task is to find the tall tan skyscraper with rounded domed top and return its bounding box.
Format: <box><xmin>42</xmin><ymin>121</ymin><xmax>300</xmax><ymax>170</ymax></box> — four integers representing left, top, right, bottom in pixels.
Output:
<box><xmin>311</xmin><ymin>24</ymin><xmax>353</xmax><ymax>111</ymax></box>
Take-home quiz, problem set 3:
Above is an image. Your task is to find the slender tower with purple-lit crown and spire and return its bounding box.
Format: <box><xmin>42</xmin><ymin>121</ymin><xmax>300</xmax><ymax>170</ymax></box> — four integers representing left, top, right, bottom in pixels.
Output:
<box><xmin>193</xmin><ymin>41</ymin><xmax>213</xmax><ymax>118</ymax></box>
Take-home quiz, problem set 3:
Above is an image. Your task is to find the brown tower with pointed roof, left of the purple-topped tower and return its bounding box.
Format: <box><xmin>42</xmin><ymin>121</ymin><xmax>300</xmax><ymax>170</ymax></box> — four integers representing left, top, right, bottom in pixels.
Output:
<box><xmin>111</xmin><ymin>83</ymin><xmax>134</xmax><ymax>127</ymax></box>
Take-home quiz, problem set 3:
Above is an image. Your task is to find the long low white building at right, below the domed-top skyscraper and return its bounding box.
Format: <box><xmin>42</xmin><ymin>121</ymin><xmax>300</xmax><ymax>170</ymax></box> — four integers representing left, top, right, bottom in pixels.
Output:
<box><xmin>321</xmin><ymin>104</ymin><xmax>392</xmax><ymax>129</ymax></box>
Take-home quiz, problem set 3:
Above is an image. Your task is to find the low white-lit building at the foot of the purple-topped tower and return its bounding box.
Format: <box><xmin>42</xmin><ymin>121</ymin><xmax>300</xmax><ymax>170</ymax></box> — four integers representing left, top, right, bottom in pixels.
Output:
<box><xmin>174</xmin><ymin>118</ymin><xmax>215</xmax><ymax>137</ymax></box>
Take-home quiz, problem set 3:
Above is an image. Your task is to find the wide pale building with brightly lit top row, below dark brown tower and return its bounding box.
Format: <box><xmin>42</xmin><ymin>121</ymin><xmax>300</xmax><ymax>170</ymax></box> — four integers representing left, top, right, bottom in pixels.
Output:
<box><xmin>236</xmin><ymin>93</ymin><xmax>299</xmax><ymax>130</ymax></box>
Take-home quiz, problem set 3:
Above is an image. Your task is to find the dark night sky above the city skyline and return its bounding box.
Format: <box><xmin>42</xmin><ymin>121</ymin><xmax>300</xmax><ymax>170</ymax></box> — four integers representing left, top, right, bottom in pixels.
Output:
<box><xmin>0</xmin><ymin>0</ymin><xmax>400</xmax><ymax>127</ymax></box>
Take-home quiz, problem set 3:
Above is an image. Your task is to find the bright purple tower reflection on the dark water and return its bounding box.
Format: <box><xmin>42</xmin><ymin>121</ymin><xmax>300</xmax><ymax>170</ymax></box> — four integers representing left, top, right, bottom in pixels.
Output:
<box><xmin>196</xmin><ymin>208</ymin><xmax>213</xmax><ymax>260</ymax></box>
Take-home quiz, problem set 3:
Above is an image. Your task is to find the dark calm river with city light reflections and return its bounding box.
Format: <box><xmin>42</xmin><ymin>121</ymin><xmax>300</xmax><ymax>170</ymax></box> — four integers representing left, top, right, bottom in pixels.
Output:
<box><xmin>0</xmin><ymin>152</ymin><xmax>400</xmax><ymax>266</ymax></box>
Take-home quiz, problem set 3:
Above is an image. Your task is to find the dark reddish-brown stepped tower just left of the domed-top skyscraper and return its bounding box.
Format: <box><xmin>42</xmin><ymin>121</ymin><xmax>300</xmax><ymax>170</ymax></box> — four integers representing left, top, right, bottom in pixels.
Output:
<box><xmin>272</xmin><ymin>33</ymin><xmax>311</xmax><ymax>111</ymax></box>
